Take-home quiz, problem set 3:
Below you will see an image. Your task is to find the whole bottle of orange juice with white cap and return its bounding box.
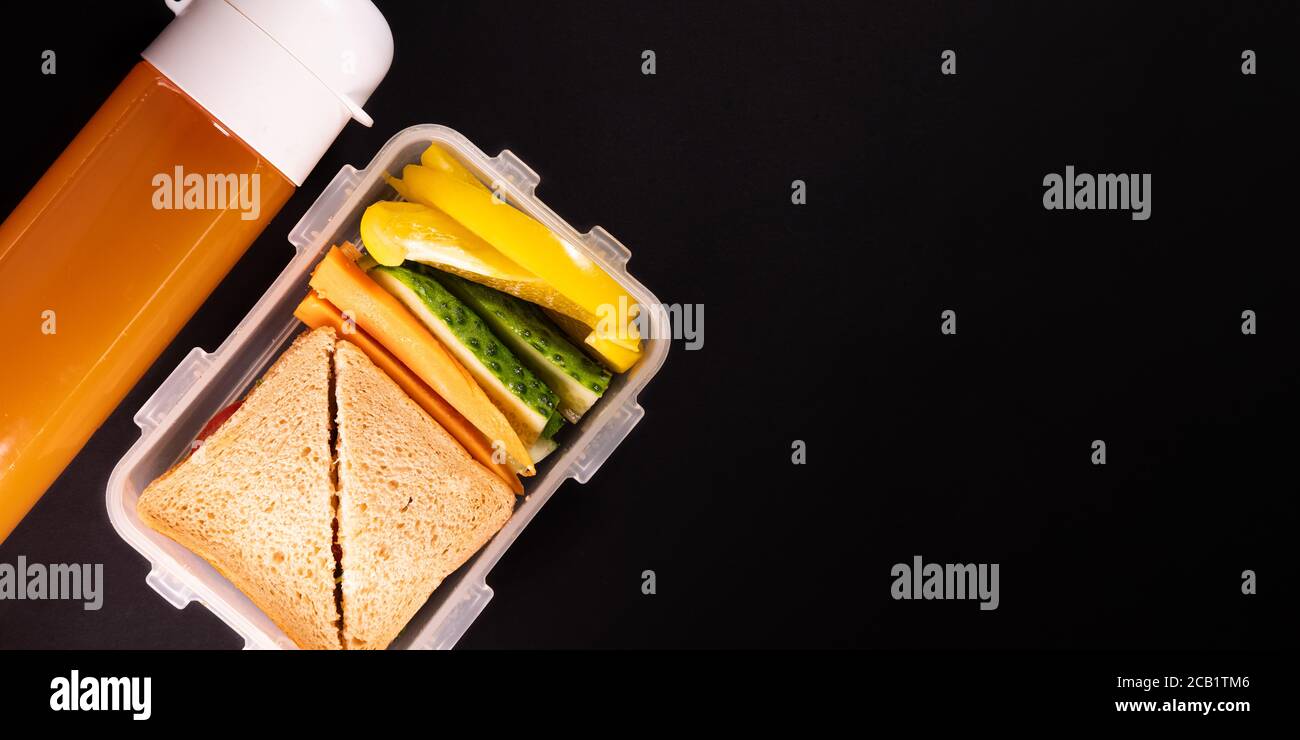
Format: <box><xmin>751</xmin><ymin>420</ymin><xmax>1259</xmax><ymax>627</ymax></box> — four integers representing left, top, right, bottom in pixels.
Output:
<box><xmin>0</xmin><ymin>0</ymin><xmax>393</xmax><ymax>541</ymax></box>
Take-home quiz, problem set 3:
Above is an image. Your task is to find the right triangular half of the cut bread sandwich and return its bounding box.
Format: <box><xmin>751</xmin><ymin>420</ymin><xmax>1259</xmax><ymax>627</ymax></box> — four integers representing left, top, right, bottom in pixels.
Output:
<box><xmin>334</xmin><ymin>339</ymin><xmax>515</xmax><ymax>649</ymax></box>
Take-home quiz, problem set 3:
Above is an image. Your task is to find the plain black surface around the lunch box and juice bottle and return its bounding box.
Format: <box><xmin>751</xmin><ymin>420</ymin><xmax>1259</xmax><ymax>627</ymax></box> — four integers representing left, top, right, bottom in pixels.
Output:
<box><xmin>0</xmin><ymin>0</ymin><xmax>1300</xmax><ymax>649</ymax></box>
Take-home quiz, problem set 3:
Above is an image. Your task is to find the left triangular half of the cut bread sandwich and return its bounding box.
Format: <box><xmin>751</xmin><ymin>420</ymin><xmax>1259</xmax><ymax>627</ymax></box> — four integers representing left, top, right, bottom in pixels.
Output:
<box><xmin>137</xmin><ymin>328</ymin><xmax>341</xmax><ymax>649</ymax></box>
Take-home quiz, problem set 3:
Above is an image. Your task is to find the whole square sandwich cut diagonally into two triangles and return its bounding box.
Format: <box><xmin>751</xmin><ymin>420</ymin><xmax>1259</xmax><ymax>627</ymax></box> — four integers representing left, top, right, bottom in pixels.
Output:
<box><xmin>137</xmin><ymin>328</ymin><xmax>515</xmax><ymax>649</ymax></box>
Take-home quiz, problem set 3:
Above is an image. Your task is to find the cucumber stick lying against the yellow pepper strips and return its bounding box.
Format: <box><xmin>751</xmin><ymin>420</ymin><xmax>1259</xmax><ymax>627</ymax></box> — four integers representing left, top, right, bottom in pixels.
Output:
<box><xmin>438</xmin><ymin>274</ymin><xmax>610</xmax><ymax>421</ymax></box>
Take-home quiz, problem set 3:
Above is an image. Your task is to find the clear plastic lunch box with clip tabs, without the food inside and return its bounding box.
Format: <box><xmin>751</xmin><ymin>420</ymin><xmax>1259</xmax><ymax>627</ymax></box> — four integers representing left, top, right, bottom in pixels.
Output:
<box><xmin>107</xmin><ymin>125</ymin><xmax>671</xmax><ymax>649</ymax></box>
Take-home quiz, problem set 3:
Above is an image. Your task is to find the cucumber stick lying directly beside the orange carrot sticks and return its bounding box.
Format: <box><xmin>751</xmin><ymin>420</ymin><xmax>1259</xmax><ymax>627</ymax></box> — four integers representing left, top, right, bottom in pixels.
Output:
<box><xmin>368</xmin><ymin>263</ymin><xmax>564</xmax><ymax>447</ymax></box>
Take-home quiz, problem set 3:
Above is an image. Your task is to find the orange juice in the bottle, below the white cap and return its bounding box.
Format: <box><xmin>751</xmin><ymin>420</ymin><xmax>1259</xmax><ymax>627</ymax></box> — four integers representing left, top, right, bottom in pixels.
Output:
<box><xmin>0</xmin><ymin>61</ymin><xmax>294</xmax><ymax>540</ymax></box>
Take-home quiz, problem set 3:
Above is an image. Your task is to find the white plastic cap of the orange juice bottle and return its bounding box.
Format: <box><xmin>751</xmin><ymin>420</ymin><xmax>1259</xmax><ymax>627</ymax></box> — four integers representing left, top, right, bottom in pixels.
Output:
<box><xmin>143</xmin><ymin>0</ymin><xmax>393</xmax><ymax>185</ymax></box>
